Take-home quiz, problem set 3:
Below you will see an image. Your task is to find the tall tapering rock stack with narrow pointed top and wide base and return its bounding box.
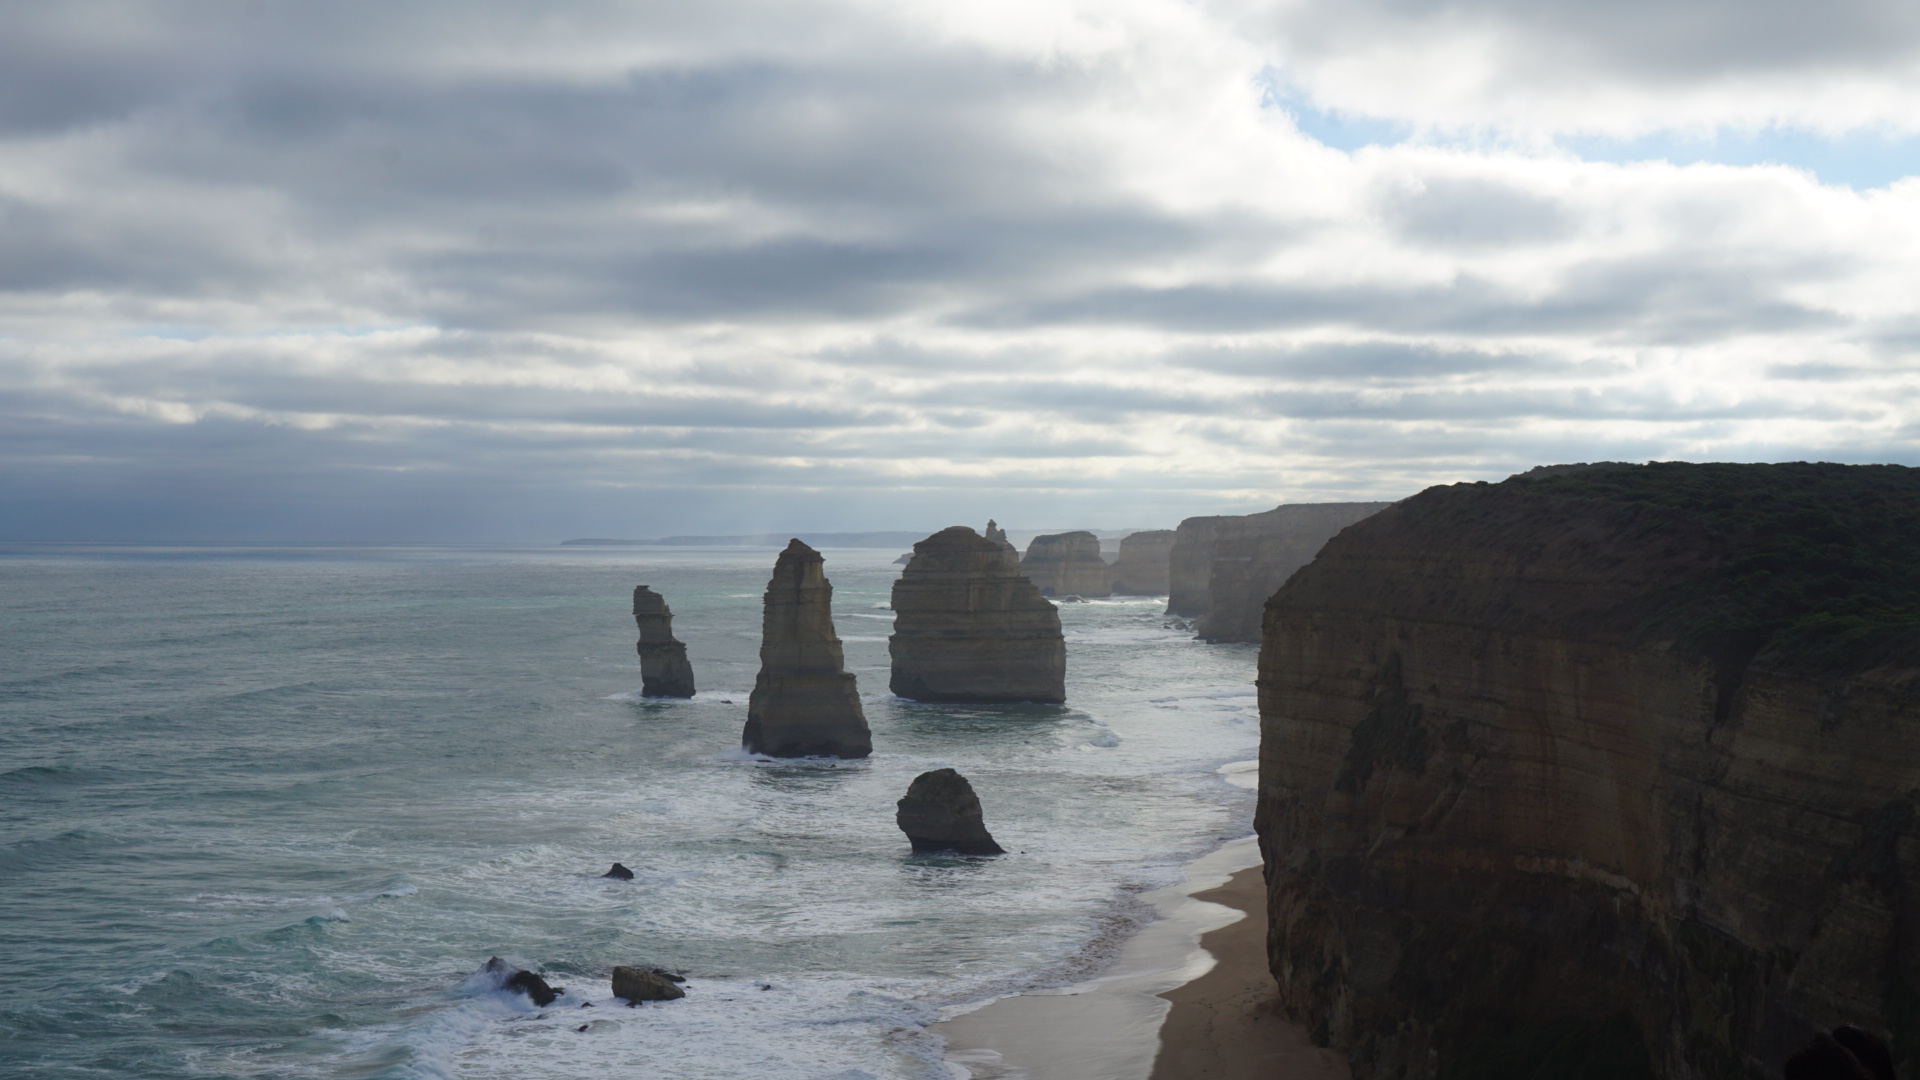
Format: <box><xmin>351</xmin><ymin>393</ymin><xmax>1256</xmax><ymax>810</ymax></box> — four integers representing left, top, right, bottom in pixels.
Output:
<box><xmin>739</xmin><ymin>540</ymin><xmax>874</xmax><ymax>757</ymax></box>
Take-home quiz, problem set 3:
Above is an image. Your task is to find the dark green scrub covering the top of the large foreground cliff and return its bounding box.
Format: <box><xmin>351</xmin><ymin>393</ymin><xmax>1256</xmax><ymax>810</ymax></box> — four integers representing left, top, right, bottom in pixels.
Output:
<box><xmin>1501</xmin><ymin>461</ymin><xmax>1920</xmax><ymax>671</ymax></box>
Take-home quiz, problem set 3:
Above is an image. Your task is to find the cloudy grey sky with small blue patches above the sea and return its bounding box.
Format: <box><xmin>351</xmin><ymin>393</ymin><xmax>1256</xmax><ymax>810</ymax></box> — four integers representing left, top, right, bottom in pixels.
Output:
<box><xmin>0</xmin><ymin>0</ymin><xmax>1920</xmax><ymax>544</ymax></box>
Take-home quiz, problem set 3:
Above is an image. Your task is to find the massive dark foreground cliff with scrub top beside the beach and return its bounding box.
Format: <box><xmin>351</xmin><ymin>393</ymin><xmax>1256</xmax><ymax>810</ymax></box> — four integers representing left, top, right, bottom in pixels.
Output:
<box><xmin>1256</xmin><ymin>463</ymin><xmax>1920</xmax><ymax>1080</ymax></box>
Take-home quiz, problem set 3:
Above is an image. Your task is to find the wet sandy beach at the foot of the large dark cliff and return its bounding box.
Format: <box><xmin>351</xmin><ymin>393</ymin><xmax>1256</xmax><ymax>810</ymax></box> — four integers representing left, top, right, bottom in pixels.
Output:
<box><xmin>927</xmin><ymin>836</ymin><xmax>1348</xmax><ymax>1080</ymax></box>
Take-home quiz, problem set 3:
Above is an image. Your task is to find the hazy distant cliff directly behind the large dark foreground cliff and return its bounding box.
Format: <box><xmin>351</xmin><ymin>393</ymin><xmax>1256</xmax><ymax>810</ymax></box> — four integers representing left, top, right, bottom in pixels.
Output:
<box><xmin>1194</xmin><ymin>502</ymin><xmax>1392</xmax><ymax>642</ymax></box>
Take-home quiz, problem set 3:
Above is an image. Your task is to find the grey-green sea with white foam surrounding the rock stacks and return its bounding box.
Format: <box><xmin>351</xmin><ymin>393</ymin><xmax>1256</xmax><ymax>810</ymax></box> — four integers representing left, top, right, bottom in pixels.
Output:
<box><xmin>0</xmin><ymin>546</ymin><xmax>1258</xmax><ymax>1080</ymax></box>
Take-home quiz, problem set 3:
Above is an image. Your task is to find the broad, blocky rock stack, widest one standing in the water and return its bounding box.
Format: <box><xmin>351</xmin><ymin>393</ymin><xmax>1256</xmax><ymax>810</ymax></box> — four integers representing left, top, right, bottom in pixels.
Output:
<box><xmin>887</xmin><ymin>525</ymin><xmax>1068</xmax><ymax>703</ymax></box>
